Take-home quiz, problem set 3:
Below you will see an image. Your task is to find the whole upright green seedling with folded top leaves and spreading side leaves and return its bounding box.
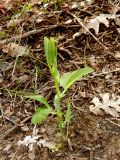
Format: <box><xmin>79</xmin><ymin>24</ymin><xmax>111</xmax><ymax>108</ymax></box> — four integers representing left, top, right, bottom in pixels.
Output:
<box><xmin>26</xmin><ymin>37</ymin><xmax>93</xmax><ymax>140</ymax></box>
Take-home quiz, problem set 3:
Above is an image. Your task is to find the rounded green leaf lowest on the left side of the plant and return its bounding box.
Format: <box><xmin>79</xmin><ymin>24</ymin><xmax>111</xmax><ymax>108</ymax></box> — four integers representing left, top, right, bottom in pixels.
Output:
<box><xmin>32</xmin><ymin>107</ymin><xmax>51</xmax><ymax>124</ymax></box>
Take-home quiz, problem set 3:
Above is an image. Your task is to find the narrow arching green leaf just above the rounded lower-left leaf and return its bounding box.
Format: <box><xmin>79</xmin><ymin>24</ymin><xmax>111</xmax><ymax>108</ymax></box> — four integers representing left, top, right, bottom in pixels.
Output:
<box><xmin>25</xmin><ymin>95</ymin><xmax>50</xmax><ymax>108</ymax></box>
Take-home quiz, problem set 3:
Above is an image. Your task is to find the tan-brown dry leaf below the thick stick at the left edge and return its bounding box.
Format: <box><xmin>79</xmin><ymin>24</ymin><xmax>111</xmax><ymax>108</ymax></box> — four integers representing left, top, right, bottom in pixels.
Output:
<box><xmin>2</xmin><ymin>43</ymin><xmax>29</xmax><ymax>57</ymax></box>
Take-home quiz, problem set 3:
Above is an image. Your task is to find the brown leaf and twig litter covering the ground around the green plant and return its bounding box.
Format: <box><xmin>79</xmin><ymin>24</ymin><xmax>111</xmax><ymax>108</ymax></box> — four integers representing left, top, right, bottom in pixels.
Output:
<box><xmin>0</xmin><ymin>0</ymin><xmax>120</xmax><ymax>160</ymax></box>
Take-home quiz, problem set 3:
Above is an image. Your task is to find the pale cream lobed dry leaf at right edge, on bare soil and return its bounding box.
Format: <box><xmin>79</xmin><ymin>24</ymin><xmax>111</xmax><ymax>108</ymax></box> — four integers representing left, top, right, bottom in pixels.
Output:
<box><xmin>90</xmin><ymin>93</ymin><xmax>120</xmax><ymax>117</ymax></box>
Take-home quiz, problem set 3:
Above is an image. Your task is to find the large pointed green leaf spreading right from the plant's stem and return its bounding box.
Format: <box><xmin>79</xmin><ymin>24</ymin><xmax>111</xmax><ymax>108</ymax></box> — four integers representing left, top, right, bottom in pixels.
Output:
<box><xmin>59</xmin><ymin>67</ymin><xmax>94</xmax><ymax>90</ymax></box>
